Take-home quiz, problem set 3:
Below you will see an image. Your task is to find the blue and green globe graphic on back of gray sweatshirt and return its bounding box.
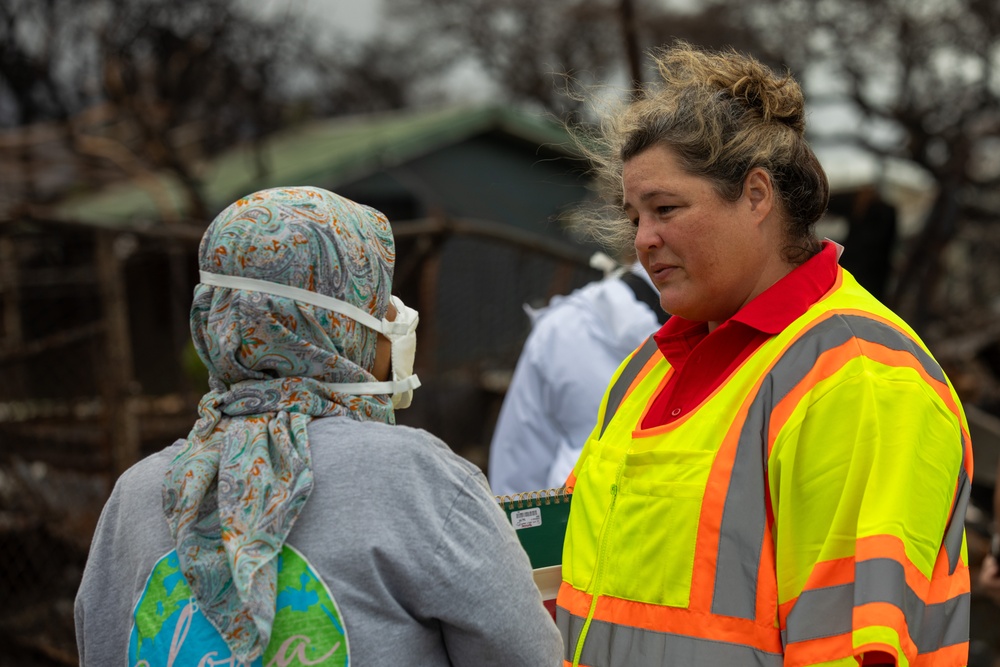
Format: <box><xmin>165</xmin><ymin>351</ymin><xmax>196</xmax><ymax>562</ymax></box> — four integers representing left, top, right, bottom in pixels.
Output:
<box><xmin>128</xmin><ymin>544</ymin><xmax>349</xmax><ymax>667</ymax></box>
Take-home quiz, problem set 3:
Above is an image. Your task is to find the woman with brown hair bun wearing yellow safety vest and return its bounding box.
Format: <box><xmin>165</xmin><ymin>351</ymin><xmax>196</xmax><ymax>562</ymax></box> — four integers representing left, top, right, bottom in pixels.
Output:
<box><xmin>557</xmin><ymin>43</ymin><xmax>972</xmax><ymax>667</ymax></box>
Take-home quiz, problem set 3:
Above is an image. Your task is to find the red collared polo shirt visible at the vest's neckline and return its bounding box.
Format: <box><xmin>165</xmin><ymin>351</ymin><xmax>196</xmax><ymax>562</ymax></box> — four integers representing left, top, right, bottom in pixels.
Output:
<box><xmin>642</xmin><ymin>241</ymin><xmax>840</xmax><ymax>428</ymax></box>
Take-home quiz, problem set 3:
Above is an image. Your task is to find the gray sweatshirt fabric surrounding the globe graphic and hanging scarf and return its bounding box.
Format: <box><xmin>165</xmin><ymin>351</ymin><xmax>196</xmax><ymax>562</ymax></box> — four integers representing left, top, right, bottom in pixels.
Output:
<box><xmin>76</xmin><ymin>418</ymin><xmax>562</xmax><ymax>667</ymax></box>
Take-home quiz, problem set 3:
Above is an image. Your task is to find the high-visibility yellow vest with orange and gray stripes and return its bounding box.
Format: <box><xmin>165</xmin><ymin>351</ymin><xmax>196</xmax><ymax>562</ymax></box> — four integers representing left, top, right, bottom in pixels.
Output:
<box><xmin>557</xmin><ymin>269</ymin><xmax>972</xmax><ymax>667</ymax></box>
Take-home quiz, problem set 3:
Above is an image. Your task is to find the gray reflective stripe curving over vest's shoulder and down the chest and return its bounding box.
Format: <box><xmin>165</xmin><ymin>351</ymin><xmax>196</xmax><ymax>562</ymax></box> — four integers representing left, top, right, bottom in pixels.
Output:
<box><xmin>712</xmin><ymin>315</ymin><xmax>952</xmax><ymax>619</ymax></box>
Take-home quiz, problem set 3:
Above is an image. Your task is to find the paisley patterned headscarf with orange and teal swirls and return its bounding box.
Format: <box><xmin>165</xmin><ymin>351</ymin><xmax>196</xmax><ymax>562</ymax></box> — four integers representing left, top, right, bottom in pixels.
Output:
<box><xmin>163</xmin><ymin>187</ymin><xmax>395</xmax><ymax>664</ymax></box>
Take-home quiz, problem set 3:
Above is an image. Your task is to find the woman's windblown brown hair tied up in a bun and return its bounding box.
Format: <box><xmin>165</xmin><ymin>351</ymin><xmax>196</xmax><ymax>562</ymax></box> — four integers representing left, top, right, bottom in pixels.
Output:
<box><xmin>571</xmin><ymin>42</ymin><xmax>830</xmax><ymax>264</ymax></box>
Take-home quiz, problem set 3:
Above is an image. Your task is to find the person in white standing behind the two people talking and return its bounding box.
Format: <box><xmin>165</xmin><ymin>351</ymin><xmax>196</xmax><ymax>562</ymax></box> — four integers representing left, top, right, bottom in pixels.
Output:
<box><xmin>487</xmin><ymin>258</ymin><xmax>667</xmax><ymax>495</ymax></box>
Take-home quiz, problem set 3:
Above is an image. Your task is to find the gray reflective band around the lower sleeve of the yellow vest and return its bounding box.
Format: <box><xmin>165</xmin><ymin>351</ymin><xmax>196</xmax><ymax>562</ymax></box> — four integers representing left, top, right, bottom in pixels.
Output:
<box><xmin>783</xmin><ymin>558</ymin><xmax>970</xmax><ymax>653</ymax></box>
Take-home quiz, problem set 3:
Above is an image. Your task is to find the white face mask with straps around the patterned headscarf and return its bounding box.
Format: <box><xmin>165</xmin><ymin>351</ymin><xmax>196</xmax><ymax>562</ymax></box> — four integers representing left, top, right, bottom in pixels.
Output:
<box><xmin>199</xmin><ymin>271</ymin><xmax>420</xmax><ymax>409</ymax></box>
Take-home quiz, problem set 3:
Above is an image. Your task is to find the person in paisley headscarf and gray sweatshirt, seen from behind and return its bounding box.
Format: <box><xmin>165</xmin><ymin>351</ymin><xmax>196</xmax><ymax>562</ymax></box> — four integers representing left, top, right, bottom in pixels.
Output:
<box><xmin>75</xmin><ymin>187</ymin><xmax>562</xmax><ymax>667</ymax></box>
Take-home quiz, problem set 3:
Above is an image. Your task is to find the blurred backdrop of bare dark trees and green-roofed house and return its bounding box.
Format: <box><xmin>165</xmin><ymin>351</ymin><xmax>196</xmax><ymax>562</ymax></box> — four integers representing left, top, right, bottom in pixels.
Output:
<box><xmin>0</xmin><ymin>0</ymin><xmax>1000</xmax><ymax>667</ymax></box>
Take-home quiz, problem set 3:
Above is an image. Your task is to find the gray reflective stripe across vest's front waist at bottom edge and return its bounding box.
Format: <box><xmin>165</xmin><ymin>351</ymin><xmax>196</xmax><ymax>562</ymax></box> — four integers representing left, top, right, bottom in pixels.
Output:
<box><xmin>556</xmin><ymin>607</ymin><xmax>784</xmax><ymax>667</ymax></box>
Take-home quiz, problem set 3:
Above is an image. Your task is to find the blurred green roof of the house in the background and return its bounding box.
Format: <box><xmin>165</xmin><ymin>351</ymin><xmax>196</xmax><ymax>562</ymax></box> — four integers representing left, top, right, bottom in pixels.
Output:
<box><xmin>53</xmin><ymin>107</ymin><xmax>574</xmax><ymax>228</ymax></box>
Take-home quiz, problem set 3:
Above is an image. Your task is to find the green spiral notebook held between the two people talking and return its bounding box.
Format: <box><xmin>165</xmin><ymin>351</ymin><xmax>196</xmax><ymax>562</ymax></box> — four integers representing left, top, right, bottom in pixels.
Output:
<box><xmin>496</xmin><ymin>488</ymin><xmax>573</xmax><ymax>617</ymax></box>
